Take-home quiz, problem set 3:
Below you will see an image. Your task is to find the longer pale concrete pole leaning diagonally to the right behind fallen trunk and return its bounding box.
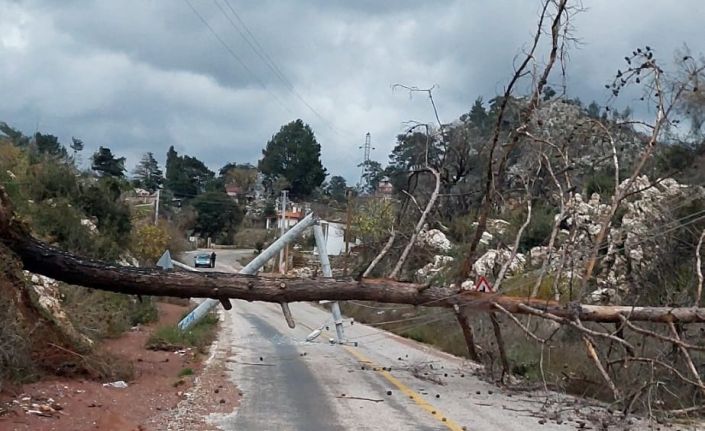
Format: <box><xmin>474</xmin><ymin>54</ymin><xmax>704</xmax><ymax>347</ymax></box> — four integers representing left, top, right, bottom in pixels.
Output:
<box><xmin>179</xmin><ymin>213</ymin><xmax>318</xmax><ymax>331</ymax></box>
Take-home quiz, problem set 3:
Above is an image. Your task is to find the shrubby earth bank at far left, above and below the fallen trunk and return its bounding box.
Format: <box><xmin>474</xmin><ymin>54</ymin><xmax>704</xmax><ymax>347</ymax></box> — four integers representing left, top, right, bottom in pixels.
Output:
<box><xmin>0</xmin><ymin>124</ymin><xmax>168</xmax><ymax>388</ymax></box>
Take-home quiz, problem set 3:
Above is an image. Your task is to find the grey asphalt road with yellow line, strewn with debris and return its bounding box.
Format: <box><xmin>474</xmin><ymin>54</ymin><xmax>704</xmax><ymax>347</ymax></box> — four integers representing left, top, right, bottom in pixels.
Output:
<box><xmin>179</xmin><ymin>250</ymin><xmax>612</xmax><ymax>431</ymax></box>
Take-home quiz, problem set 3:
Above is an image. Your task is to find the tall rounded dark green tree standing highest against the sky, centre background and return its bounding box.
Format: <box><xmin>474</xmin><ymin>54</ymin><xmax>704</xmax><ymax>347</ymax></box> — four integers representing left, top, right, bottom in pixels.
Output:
<box><xmin>259</xmin><ymin>119</ymin><xmax>326</xmax><ymax>199</ymax></box>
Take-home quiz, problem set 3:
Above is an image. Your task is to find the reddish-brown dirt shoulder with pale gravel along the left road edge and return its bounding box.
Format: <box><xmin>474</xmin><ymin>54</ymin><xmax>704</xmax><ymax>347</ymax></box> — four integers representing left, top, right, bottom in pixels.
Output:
<box><xmin>0</xmin><ymin>303</ymin><xmax>239</xmax><ymax>431</ymax></box>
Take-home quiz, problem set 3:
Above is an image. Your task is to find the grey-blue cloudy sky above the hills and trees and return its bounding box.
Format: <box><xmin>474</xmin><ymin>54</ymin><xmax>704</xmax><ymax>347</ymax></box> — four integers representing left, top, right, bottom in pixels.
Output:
<box><xmin>0</xmin><ymin>0</ymin><xmax>705</xmax><ymax>182</ymax></box>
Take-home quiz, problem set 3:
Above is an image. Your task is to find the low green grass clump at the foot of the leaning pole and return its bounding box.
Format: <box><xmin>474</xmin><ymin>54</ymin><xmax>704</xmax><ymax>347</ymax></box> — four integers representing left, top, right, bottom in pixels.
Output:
<box><xmin>146</xmin><ymin>313</ymin><xmax>218</xmax><ymax>353</ymax></box>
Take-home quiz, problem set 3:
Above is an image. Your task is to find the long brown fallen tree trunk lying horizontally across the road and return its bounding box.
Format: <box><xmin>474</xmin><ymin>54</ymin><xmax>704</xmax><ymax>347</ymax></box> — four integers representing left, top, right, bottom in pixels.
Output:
<box><xmin>0</xmin><ymin>190</ymin><xmax>705</xmax><ymax>323</ymax></box>
